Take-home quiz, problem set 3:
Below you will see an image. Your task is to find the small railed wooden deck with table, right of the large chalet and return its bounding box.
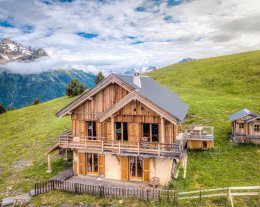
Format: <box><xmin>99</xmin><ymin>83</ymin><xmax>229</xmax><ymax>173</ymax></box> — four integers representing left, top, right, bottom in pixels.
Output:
<box><xmin>185</xmin><ymin>125</ymin><xmax>214</xmax><ymax>141</ymax></box>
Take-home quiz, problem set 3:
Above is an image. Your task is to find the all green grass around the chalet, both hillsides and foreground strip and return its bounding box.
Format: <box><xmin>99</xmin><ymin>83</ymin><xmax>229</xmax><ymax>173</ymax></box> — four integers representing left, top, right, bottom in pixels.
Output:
<box><xmin>0</xmin><ymin>51</ymin><xmax>260</xmax><ymax>207</ymax></box>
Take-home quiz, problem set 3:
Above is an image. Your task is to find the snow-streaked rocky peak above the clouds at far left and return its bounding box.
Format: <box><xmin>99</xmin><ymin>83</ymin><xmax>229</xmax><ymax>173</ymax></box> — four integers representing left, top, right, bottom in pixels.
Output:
<box><xmin>0</xmin><ymin>38</ymin><xmax>48</xmax><ymax>64</ymax></box>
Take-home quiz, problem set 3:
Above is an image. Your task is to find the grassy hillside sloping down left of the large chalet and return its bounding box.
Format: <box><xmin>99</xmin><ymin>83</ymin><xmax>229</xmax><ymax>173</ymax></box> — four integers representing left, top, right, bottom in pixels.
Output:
<box><xmin>0</xmin><ymin>97</ymin><xmax>76</xmax><ymax>198</ymax></box>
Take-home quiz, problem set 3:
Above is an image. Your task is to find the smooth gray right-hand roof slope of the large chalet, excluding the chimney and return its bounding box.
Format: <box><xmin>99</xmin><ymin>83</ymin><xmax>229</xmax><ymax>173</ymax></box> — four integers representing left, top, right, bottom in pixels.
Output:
<box><xmin>114</xmin><ymin>74</ymin><xmax>188</xmax><ymax>121</ymax></box>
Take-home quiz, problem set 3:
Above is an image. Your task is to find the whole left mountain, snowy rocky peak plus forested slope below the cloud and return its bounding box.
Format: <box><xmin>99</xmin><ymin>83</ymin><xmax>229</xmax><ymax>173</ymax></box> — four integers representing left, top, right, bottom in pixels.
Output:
<box><xmin>0</xmin><ymin>39</ymin><xmax>96</xmax><ymax>108</ymax></box>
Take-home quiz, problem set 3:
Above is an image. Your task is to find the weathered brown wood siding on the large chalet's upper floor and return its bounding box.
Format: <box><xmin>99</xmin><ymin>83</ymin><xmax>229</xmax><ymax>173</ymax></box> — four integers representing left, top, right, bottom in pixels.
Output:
<box><xmin>71</xmin><ymin>84</ymin><xmax>178</xmax><ymax>143</ymax></box>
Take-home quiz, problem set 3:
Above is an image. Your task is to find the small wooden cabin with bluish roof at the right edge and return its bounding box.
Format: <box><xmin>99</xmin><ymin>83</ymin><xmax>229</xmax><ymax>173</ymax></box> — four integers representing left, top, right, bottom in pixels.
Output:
<box><xmin>229</xmin><ymin>109</ymin><xmax>260</xmax><ymax>144</ymax></box>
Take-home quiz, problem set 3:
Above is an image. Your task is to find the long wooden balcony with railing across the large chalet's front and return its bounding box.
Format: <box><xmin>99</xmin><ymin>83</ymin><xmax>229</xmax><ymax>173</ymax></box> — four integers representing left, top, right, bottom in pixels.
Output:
<box><xmin>59</xmin><ymin>133</ymin><xmax>186</xmax><ymax>159</ymax></box>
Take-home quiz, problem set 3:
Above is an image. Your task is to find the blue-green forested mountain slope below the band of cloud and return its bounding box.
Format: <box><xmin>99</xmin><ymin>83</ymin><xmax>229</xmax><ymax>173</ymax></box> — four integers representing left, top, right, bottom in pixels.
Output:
<box><xmin>0</xmin><ymin>70</ymin><xmax>96</xmax><ymax>108</ymax></box>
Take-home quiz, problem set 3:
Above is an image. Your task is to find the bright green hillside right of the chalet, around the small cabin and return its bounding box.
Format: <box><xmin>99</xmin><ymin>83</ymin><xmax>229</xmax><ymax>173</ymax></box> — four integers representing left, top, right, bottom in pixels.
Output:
<box><xmin>148</xmin><ymin>51</ymin><xmax>260</xmax><ymax>190</ymax></box>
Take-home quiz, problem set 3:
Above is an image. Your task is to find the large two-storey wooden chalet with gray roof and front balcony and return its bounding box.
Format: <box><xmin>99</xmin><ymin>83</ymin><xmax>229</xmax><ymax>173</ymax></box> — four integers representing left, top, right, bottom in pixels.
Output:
<box><xmin>47</xmin><ymin>74</ymin><xmax>188</xmax><ymax>185</ymax></box>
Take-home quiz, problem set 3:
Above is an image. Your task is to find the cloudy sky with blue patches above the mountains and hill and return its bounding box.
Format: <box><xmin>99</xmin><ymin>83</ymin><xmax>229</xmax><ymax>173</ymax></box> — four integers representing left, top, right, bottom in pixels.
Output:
<box><xmin>0</xmin><ymin>0</ymin><xmax>260</xmax><ymax>72</ymax></box>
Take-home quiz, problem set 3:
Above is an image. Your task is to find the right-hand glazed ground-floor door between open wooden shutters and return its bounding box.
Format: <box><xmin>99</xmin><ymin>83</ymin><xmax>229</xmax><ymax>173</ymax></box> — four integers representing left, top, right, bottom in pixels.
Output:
<box><xmin>129</xmin><ymin>157</ymin><xmax>143</xmax><ymax>180</ymax></box>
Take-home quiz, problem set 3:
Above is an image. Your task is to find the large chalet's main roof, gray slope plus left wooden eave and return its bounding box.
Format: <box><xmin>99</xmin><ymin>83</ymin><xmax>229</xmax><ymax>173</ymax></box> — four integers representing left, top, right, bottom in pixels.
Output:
<box><xmin>56</xmin><ymin>74</ymin><xmax>188</xmax><ymax>121</ymax></box>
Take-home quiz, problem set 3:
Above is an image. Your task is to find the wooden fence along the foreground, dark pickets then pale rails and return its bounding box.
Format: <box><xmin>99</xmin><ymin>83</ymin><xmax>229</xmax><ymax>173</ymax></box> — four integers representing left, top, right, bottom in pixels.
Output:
<box><xmin>34</xmin><ymin>180</ymin><xmax>260</xmax><ymax>206</ymax></box>
